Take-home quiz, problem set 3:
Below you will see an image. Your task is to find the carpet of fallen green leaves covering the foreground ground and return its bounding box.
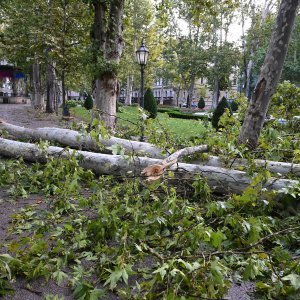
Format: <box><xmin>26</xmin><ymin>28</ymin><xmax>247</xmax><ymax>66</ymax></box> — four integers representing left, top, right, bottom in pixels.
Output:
<box><xmin>0</xmin><ymin>154</ymin><xmax>299</xmax><ymax>300</ymax></box>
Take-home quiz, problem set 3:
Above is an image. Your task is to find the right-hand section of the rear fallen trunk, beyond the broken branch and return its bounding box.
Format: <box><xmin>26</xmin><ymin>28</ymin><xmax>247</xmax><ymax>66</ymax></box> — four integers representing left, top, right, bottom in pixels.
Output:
<box><xmin>197</xmin><ymin>156</ymin><xmax>300</xmax><ymax>177</ymax></box>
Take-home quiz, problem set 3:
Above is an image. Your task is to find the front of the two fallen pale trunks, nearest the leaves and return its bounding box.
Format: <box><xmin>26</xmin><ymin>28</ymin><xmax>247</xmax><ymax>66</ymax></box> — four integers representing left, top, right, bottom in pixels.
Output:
<box><xmin>0</xmin><ymin>138</ymin><xmax>299</xmax><ymax>194</ymax></box>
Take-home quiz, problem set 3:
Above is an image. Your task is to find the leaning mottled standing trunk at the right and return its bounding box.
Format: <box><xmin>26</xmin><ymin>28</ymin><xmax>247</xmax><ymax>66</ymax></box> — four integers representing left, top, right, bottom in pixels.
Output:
<box><xmin>239</xmin><ymin>0</ymin><xmax>299</xmax><ymax>149</ymax></box>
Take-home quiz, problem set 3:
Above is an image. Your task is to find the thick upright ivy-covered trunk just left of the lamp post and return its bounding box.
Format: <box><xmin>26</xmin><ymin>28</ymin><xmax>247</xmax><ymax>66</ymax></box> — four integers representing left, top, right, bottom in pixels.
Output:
<box><xmin>91</xmin><ymin>0</ymin><xmax>125</xmax><ymax>129</ymax></box>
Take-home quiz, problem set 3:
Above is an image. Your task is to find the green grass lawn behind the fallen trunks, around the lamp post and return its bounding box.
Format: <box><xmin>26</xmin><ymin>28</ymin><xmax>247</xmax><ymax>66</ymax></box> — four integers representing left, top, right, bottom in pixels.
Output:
<box><xmin>71</xmin><ymin>106</ymin><xmax>206</xmax><ymax>138</ymax></box>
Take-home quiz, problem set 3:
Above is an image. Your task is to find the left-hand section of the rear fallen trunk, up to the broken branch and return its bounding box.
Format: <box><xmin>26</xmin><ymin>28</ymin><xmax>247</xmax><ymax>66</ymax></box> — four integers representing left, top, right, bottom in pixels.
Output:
<box><xmin>0</xmin><ymin>120</ymin><xmax>165</xmax><ymax>158</ymax></box>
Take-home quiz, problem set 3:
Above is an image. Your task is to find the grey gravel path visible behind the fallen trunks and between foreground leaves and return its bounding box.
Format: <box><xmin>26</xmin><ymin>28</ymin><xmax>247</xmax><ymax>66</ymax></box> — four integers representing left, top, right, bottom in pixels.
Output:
<box><xmin>0</xmin><ymin>104</ymin><xmax>254</xmax><ymax>300</ymax></box>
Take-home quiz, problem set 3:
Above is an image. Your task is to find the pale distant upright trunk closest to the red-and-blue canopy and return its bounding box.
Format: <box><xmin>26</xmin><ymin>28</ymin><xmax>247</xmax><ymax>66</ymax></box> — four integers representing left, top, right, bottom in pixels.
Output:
<box><xmin>32</xmin><ymin>59</ymin><xmax>44</xmax><ymax>109</ymax></box>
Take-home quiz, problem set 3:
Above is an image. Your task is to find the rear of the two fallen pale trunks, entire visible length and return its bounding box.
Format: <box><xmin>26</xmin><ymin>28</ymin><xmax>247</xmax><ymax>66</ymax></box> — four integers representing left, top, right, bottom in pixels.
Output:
<box><xmin>0</xmin><ymin>120</ymin><xmax>300</xmax><ymax>177</ymax></box>
